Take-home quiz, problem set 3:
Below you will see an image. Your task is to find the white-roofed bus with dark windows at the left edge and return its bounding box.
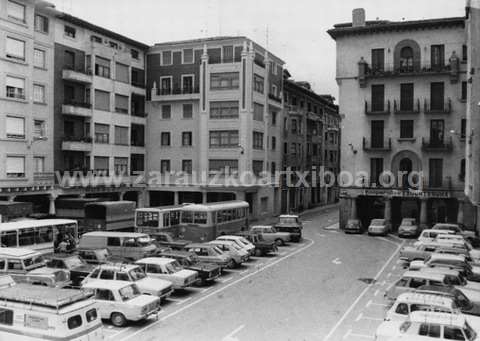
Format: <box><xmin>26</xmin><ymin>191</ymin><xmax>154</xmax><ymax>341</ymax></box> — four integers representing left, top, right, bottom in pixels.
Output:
<box><xmin>0</xmin><ymin>219</ymin><xmax>78</xmax><ymax>254</ymax></box>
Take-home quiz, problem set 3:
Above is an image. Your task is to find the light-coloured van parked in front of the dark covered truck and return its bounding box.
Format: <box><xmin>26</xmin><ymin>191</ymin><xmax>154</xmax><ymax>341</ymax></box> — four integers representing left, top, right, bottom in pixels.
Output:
<box><xmin>78</xmin><ymin>231</ymin><xmax>157</xmax><ymax>260</ymax></box>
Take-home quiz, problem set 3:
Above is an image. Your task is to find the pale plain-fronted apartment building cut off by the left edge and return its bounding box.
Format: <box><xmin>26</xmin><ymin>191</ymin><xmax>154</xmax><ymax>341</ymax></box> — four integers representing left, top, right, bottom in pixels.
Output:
<box><xmin>0</xmin><ymin>0</ymin><xmax>54</xmax><ymax>210</ymax></box>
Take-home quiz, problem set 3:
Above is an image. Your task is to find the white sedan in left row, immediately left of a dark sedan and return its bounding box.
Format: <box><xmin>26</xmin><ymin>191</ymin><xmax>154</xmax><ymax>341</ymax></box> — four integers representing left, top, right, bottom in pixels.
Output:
<box><xmin>135</xmin><ymin>257</ymin><xmax>198</xmax><ymax>289</ymax></box>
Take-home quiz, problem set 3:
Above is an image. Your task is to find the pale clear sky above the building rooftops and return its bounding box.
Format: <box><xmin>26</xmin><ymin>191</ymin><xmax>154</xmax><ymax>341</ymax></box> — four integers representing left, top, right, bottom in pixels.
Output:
<box><xmin>49</xmin><ymin>0</ymin><xmax>465</xmax><ymax>101</ymax></box>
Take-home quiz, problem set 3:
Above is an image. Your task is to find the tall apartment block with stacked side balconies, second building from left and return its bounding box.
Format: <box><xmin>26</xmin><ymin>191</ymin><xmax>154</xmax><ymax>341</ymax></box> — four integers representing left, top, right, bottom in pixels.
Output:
<box><xmin>51</xmin><ymin>12</ymin><xmax>148</xmax><ymax>206</ymax></box>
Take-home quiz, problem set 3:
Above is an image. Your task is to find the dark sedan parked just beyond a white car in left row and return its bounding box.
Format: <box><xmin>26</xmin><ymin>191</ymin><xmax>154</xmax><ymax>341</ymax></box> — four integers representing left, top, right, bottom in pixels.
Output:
<box><xmin>155</xmin><ymin>250</ymin><xmax>222</xmax><ymax>285</ymax></box>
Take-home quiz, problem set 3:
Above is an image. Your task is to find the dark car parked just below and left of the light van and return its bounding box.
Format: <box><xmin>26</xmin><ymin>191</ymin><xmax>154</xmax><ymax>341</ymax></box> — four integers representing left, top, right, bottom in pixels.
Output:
<box><xmin>45</xmin><ymin>253</ymin><xmax>95</xmax><ymax>287</ymax></box>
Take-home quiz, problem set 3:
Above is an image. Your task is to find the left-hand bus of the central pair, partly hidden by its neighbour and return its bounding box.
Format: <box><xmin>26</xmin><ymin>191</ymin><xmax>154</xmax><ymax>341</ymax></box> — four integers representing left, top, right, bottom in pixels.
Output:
<box><xmin>135</xmin><ymin>204</ymin><xmax>187</xmax><ymax>236</ymax></box>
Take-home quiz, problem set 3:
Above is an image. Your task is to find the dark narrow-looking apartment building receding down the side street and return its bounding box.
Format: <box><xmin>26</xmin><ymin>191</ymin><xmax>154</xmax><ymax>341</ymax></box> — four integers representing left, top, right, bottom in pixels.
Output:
<box><xmin>282</xmin><ymin>75</ymin><xmax>340</xmax><ymax>212</ymax></box>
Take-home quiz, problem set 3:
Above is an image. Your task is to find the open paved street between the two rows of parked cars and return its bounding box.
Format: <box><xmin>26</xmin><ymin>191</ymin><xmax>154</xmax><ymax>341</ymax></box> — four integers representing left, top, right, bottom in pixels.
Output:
<box><xmin>102</xmin><ymin>208</ymin><xmax>408</xmax><ymax>341</ymax></box>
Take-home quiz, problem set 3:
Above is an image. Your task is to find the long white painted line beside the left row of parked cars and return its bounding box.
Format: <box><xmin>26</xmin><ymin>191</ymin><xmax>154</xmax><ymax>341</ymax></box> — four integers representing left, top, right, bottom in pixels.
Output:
<box><xmin>121</xmin><ymin>238</ymin><xmax>315</xmax><ymax>341</ymax></box>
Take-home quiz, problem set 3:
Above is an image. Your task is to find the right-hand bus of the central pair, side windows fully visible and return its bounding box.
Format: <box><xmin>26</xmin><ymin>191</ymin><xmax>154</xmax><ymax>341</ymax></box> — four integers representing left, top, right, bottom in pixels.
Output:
<box><xmin>178</xmin><ymin>200</ymin><xmax>249</xmax><ymax>242</ymax></box>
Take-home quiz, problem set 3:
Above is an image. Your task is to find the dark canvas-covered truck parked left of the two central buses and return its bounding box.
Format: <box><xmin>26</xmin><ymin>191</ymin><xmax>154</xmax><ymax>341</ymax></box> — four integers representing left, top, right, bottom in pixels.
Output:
<box><xmin>81</xmin><ymin>201</ymin><xmax>136</xmax><ymax>233</ymax></box>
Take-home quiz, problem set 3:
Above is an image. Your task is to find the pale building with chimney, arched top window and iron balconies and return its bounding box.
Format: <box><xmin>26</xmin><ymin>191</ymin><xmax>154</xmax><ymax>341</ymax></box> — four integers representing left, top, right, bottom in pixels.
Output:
<box><xmin>328</xmin><ymin>9</ymin><xmax>478</xmax><ymax>227</ymax></box>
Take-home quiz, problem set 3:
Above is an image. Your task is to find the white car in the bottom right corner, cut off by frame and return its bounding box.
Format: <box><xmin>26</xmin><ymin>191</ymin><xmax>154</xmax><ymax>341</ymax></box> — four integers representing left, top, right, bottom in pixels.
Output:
<box><xmin>375</xmin><ymin>311</ymin><xmax>479</xmax><ymax>341</ymax></box>
